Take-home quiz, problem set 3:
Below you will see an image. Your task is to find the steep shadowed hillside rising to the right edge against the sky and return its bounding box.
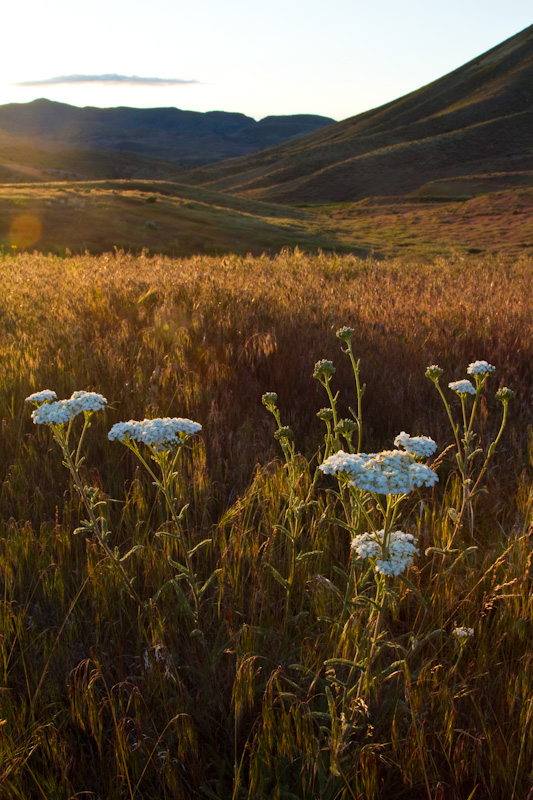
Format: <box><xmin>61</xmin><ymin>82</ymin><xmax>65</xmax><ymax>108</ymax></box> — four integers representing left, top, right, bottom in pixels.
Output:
<box><xmin>181</xmin><ymin>26</ymin><xmax>533</xmax><ymax>203</ymax></box>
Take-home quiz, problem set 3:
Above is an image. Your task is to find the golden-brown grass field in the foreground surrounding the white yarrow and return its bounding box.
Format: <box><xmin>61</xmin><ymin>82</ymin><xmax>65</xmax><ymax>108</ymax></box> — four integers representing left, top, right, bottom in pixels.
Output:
<box><xmin>0</xmin><ymin>247</ymin><xmax>533</xmax><ymax>800</ymax></box>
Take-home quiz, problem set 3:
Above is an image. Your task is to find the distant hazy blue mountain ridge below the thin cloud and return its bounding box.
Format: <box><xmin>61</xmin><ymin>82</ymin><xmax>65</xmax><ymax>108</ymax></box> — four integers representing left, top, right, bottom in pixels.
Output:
<box><xmin>0</xmin><ymin>99</ymin><xmax>334</xmax><ymax>169</ymax></box>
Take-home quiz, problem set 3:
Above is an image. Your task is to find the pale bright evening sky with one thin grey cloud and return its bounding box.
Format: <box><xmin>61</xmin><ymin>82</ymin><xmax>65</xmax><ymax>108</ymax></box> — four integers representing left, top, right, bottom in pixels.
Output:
<box><xmin>0</xmin><ymin>0</ymin><xmax>533</xmax><ymax>120</ymax></box>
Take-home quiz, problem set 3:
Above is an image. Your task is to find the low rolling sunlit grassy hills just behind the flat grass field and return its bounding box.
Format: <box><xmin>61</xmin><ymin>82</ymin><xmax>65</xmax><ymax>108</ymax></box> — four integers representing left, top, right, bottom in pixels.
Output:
<box><xmin>0</xmin><ymin>180</ymin><xmax>533</xmax><ymax>258</ymax></box>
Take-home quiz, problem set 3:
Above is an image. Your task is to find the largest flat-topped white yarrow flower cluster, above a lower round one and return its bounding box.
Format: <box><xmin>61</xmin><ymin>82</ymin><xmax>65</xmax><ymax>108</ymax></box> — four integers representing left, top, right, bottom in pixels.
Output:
<box><xmin>320</xmin><ymin>450</ymin><xmax>438</xmax><ymax>494</ymax></box>
